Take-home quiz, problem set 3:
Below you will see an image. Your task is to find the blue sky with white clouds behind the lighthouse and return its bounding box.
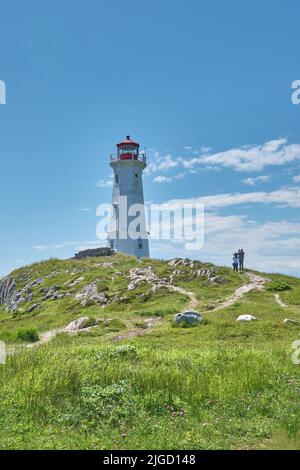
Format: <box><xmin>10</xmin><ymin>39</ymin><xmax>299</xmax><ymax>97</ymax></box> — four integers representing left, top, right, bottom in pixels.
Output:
<box><xmin>0</xmin><ymin>0</ymin><xmax>300</xmax><ymax>275</ymax></box>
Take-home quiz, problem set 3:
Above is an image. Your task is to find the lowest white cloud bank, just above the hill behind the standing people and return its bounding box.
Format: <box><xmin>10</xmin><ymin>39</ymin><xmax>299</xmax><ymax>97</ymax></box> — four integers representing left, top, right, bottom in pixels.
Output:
<box><xmin>151</xmin><ymin>213</ymin><xmax>300</xmax><ymax>276</ymax></box>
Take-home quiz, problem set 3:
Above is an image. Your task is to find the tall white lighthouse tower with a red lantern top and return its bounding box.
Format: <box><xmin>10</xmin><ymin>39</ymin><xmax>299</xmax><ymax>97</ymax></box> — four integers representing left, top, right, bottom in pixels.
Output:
<box><xmin>108</xmin><ymin>135</ymin><xmax>149</xmax><ymax>258</ymax></box>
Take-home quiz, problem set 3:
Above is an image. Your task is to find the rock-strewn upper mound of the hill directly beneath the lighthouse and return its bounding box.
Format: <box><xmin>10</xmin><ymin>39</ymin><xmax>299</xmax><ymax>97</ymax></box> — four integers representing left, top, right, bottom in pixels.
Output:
<box><xmin>0</xmin><ymin>254</ymin><xmax>243</xmax><ymax>342</ymax></box>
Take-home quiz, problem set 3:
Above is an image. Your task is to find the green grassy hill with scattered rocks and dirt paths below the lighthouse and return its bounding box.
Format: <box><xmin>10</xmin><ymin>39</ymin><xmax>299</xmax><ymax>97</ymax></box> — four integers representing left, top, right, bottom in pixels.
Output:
<box><xmin>0</xmin><ymin>255</ymin><xmax>300</xmax><ymax>449</ymax></box>
